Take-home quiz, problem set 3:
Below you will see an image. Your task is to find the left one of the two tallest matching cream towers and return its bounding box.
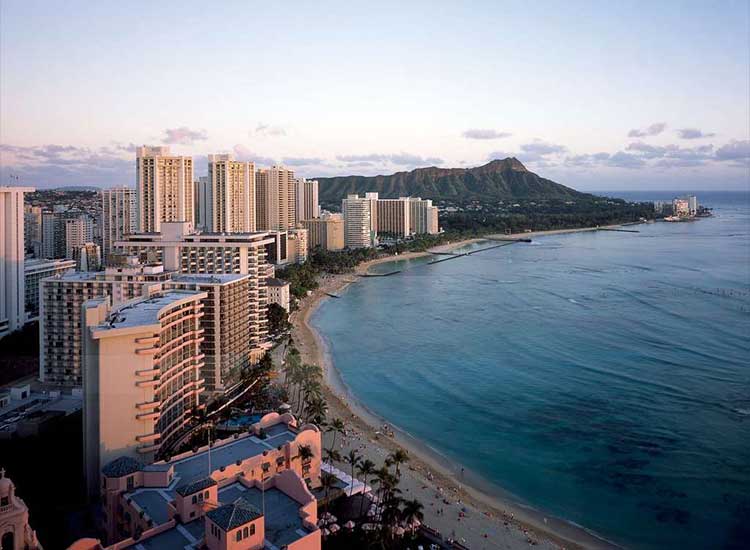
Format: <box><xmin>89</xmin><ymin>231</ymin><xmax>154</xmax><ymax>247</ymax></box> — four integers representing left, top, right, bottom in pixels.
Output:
<box><xmin>136</xmin><ymin>146</ymin><xmax>195</xmax><ymax>232</ymax></box>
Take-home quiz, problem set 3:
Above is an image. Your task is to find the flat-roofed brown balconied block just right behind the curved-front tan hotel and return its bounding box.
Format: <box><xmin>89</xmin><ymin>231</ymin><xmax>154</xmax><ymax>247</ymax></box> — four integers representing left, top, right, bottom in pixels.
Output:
<box><xmin>165</xmin><ymin>274</ymin><xmax>250</xmax><ymax>393</ymax></box>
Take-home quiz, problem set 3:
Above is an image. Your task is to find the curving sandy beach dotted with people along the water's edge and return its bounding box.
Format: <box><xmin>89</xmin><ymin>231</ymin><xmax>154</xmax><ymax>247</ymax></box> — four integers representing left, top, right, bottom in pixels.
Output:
<box><xmin>290</xmin><ymin>229</ymin><xmax>628</xmax><ymax>550</ymax></box>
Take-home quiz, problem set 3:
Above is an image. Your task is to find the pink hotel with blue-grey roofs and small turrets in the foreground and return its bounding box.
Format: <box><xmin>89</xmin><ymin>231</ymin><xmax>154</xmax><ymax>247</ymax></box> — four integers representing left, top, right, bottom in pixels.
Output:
<box><xmin>71</xmin><ymin>413</ymin><xmax>322</xmax><ymax>550</ymax></box>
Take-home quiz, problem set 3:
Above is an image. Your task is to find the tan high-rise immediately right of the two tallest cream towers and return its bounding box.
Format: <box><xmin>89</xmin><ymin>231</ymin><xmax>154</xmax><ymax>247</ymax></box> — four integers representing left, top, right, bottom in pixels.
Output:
<box><xmin>255</xmin><ymin>166</ymin><xmax>297</xmax><ymax>231</ymax></box>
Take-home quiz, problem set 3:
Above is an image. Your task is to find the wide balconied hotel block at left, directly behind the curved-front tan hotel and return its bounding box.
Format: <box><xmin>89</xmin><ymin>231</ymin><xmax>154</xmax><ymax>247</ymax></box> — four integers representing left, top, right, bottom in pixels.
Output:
<box><xmin>39</xmin><ymin>261</ymin><xmax>169</xmax><ymax>386</ymax></box>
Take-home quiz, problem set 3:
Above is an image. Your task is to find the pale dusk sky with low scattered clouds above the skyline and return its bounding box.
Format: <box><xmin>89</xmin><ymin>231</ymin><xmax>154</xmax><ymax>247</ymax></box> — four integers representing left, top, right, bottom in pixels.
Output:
<box><xmin>0</xmin><ymin>0</ymin><xmax>750</xmax><ymax>191</ymax></box>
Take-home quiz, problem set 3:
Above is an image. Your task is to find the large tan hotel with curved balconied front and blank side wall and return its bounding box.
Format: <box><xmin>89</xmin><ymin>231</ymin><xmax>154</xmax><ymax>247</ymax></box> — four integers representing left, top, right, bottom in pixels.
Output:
<box><xmin>82</xmin><ymin>290</ymin><xmax>207</xmax><ymax>494</ymax></box>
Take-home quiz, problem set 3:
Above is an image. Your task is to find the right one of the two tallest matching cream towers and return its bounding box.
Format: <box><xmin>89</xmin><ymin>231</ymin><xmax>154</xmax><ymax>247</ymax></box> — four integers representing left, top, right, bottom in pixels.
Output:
<box><xmin>204</xmin><ymin>155</ymin><xmax>256</xmax><ymax>233</ymax></box>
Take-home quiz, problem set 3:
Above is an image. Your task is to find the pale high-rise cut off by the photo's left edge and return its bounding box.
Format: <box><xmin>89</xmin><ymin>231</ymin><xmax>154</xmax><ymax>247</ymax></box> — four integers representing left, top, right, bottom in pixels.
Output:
<box><xmin>0</xmin><ymin>187</ymin><xmax>34</xmax><ymax>337</ymax></box>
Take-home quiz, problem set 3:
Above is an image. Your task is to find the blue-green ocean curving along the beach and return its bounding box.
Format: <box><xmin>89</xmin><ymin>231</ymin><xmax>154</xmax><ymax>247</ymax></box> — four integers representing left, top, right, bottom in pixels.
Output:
<box><xmin>312</xmin><ymin>193</ymin><xmax>750</xmax><ymax>549</ymax></box>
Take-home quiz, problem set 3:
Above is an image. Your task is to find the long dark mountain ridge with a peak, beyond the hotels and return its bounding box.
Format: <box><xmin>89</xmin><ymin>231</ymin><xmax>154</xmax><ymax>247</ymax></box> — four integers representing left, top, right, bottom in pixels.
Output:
<box><xmin>315</xmin><ymin>157</ymin><xmax>591</xmax><ymax>203</ymax></box>
